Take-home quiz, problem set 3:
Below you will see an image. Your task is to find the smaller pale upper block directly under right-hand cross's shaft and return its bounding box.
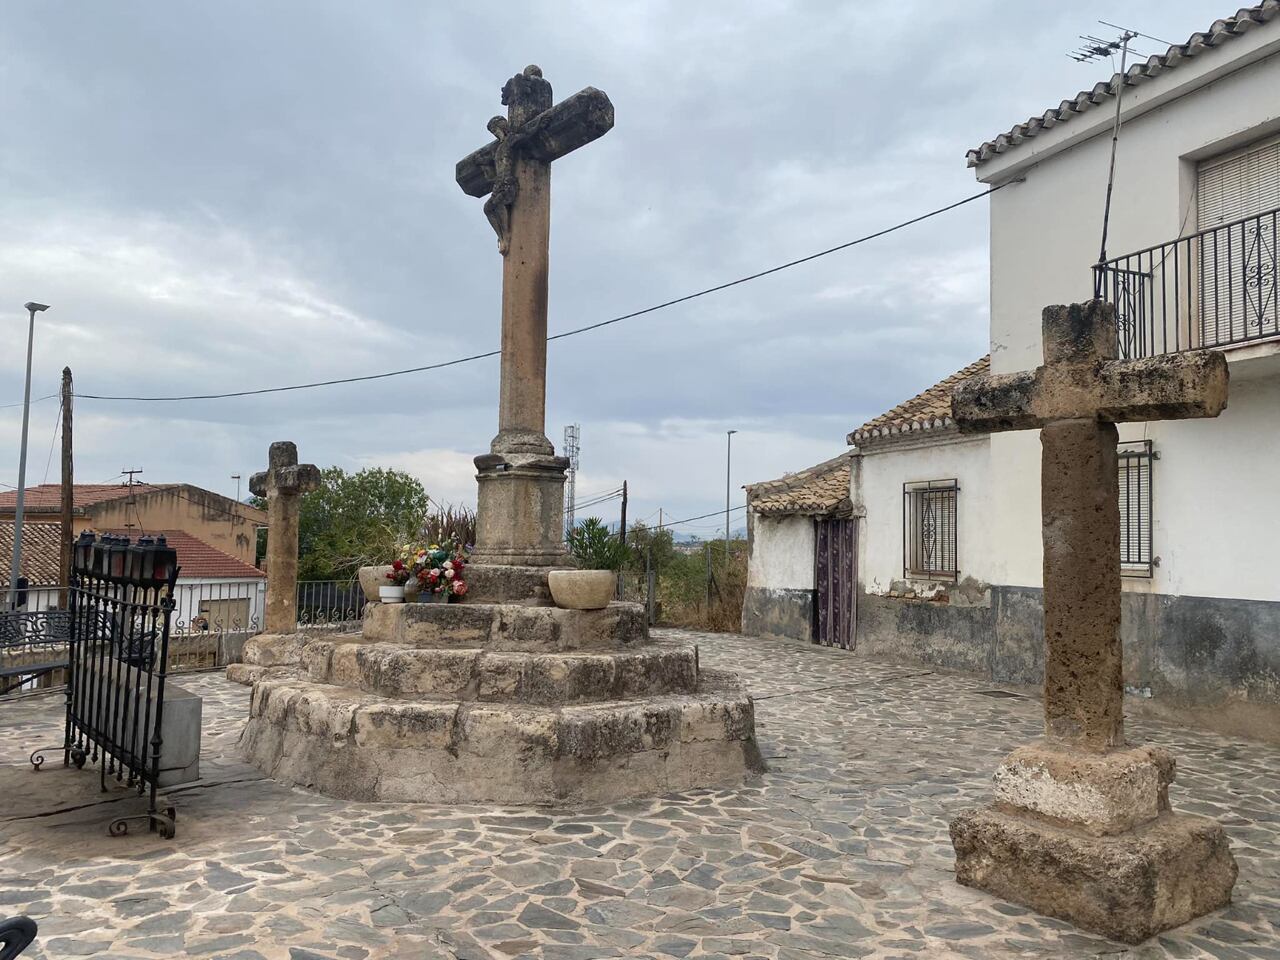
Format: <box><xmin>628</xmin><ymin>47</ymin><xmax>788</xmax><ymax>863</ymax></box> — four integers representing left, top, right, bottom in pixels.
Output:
<box><xmin>996</xmin><ymin>742</ymin><xmax>1174</xmax><ymax>836</ymax></box>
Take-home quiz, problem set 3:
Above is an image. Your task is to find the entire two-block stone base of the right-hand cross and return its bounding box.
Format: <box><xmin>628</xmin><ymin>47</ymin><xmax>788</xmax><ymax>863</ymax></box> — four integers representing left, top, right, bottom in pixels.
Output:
<box><xmin>951</xmin><ymin>745</ymin><xmax>1236</xmax><ymax>943</ymax></box>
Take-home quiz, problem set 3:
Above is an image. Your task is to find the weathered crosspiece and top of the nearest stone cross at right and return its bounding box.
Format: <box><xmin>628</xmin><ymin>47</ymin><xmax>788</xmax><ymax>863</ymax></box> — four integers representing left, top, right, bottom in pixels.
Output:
<box><xmin>951</xmin><ymin>301</ymin><xmax>1228</xmax><ymax>433</ymax></box>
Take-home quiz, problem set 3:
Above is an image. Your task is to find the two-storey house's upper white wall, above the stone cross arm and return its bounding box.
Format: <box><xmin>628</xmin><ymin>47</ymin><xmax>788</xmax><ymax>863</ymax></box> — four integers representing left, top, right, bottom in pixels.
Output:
<box><xmin>978</xmin><ymin>43</ymin><xmax>1280</xmax><ymax>374</ymax></box>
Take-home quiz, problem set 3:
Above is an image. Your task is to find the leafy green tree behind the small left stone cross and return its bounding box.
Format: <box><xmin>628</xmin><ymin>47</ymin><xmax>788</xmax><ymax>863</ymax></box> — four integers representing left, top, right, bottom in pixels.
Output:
<box><xmin>253</xmin><ymin>467</ymin><xmax>431</xmax><ymax>580</ymax></box>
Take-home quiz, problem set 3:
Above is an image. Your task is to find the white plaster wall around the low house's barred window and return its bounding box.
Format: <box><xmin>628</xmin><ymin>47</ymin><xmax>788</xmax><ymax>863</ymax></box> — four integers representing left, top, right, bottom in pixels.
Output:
<box><xmin>854</xmin><ymin>436</ymin><xmax>988</xmax><ymax>593</ymax></box>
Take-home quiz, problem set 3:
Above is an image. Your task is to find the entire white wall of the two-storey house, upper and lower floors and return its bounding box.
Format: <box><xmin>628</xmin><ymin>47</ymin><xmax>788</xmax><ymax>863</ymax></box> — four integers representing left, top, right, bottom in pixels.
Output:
<box><xmin>961</xmin><ymin>45</ymin><xmax>1280</xmax><ymax>600</ymax></box>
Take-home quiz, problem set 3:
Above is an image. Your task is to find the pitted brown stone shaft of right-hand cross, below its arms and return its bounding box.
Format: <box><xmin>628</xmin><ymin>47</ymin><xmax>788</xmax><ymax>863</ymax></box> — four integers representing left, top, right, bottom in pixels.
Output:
<box><xmin>1041</xmin><ymin>420</ymin><xmax>1124</xmax><ymax>750</ymax></box>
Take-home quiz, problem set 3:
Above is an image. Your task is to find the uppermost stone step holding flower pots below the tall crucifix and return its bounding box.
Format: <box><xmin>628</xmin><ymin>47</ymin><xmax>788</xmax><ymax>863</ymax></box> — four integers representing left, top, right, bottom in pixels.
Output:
<box><xmin>361</xmin><ymin>600</ymin><xmax>649</xmax><ymax>653</ymax></box>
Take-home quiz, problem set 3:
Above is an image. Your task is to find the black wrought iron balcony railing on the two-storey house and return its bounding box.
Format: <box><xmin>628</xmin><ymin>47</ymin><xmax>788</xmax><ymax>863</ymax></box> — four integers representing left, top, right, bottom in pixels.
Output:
<box><xmin>1093</xmin><ymin>210</ymin><xmax>1280</xmax><ymax>360</ymax></box>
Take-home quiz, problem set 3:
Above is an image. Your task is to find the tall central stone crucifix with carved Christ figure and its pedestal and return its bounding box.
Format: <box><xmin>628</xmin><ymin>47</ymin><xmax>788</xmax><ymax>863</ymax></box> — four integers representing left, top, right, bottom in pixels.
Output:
<box><xmin>457</xmin><ymin>67</ymin><xmax>613</xmax><ymax>566</ymax></box>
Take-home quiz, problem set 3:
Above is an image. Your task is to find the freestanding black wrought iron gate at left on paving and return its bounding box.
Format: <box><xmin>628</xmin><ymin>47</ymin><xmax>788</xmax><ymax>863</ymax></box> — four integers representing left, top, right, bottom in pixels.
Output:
<box><xmin>31</xmin><ymin>532</ymin><xmax>178</xmax><ymax>837</ymax></box>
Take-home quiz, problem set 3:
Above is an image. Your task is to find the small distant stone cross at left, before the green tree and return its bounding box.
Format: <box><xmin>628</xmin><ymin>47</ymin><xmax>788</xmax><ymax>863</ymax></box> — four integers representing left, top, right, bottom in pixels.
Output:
<box><xmin>248</xmin><ymin>440</ymin><xmax>320</xmax><ymax>634</ymax></box>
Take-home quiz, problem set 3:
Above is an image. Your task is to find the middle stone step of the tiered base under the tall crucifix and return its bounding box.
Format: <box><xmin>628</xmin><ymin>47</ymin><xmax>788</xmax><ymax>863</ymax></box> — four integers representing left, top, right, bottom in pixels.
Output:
<box><xmin>300</xmin><ymin>640</ymin><xmax>698</xmax><ymax>704</ymax></box>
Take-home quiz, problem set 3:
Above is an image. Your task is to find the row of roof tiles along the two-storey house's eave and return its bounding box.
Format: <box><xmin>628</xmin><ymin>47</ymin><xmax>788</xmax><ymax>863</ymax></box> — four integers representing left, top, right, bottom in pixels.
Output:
<box><xmin>965</xmin><ymin>0</ymin><xmax>1280</xmax><ymax>166</ymax></box>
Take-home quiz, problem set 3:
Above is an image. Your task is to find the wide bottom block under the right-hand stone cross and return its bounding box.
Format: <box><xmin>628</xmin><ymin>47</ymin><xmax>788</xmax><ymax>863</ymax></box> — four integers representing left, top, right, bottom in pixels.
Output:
<box><xmin>951</xmin><ymin>809</ymin><xmax>1236</xmax><ymax>943</ymax></box>
